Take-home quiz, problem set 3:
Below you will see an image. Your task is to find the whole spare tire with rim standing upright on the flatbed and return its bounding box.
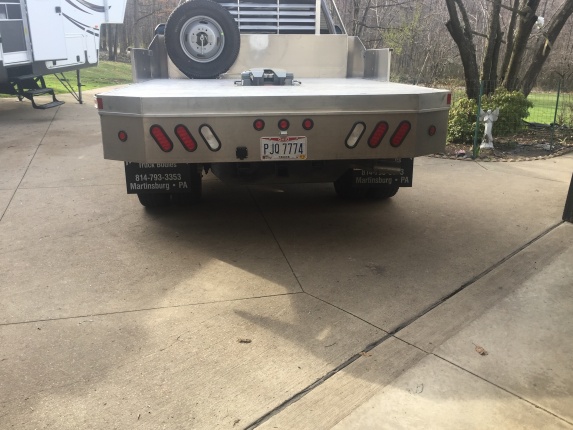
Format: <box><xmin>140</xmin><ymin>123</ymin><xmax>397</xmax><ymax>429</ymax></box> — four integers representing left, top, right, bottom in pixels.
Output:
<box><xmin>165</xmin><ymin>0</ymin><xmax>241</xmax><ymax>79</ymax></box>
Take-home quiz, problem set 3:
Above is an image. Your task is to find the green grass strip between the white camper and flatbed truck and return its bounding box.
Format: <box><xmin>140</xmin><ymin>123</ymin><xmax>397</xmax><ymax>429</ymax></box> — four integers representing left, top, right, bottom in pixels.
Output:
<box><xmin>45</xmin><ymin>61</ymin><xmax>132</xmax><ymax>94</ymax></box>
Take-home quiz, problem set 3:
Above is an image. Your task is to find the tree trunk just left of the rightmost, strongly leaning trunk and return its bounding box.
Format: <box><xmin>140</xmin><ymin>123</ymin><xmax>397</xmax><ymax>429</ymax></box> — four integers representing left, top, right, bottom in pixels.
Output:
<box><xmin>503</xmin><ymin>0</ymin><xmax>540</xmax><ymax>91</ymax></box>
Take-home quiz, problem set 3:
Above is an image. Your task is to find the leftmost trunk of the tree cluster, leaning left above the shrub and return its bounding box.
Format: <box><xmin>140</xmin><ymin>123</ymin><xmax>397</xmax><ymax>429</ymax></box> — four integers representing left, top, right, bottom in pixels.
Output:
<box><xmin>446</xmin><ymin>0</ymin><xmax>479</xmax><ymax>99</ymax></box>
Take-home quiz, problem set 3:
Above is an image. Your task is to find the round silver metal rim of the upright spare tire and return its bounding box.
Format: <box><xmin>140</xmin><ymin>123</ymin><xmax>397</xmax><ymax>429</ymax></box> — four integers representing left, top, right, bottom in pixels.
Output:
<box><xmin>179</xmin><ymin>16</ymin><xmax>225</xmax><ymax>63</ymax></box>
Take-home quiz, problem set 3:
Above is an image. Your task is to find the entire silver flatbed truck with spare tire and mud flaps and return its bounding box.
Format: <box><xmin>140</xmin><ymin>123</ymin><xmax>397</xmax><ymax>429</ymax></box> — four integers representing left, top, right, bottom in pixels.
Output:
<box><xmin>97</xmin><ymin>0</ymin><xmax>451</xmax><ymax>207</ymax></box>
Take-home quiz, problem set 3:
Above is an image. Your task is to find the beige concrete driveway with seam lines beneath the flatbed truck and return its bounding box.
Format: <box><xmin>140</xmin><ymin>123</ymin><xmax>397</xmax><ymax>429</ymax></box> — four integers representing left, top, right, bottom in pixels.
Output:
<box><xmin>0</xmin><ymin>95</ymin><xmax>573</xmax><ymax>430</ymax></box>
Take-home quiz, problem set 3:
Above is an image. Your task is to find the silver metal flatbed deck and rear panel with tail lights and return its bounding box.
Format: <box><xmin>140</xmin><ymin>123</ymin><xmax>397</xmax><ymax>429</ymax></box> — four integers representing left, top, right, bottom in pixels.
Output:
<box><xmin>98</xmin><ymin>79</ymin><xmax>449</xmax><ymax>163</ymax></box>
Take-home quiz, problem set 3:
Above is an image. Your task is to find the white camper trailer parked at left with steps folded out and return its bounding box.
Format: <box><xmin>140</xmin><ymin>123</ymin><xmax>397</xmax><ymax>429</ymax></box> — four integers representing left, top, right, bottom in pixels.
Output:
<box><xmin>0</xmin><ymin>0</ymin><xmax>126</xmax><ymax>109</ymax></box>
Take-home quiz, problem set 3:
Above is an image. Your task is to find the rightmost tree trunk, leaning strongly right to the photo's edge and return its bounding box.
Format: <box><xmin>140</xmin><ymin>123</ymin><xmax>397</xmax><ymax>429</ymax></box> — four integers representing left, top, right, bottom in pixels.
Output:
<box><xmin>521</xmin><ymin>0</ymin><xmax>573</xmax><ymax>96</ymax></box>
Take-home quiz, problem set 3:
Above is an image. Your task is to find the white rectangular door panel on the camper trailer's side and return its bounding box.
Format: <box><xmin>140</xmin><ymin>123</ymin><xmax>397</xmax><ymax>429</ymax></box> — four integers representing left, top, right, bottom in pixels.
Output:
<box><xmin>26</xmin><ymin>0</ymin><xmax>68</xmax><ymax>61</ymax></box>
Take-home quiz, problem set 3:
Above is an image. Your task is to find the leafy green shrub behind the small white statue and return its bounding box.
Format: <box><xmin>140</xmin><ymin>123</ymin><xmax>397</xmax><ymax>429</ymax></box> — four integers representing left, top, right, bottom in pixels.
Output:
<box><xmin>448</xmin><ymin>88</ymin><xmax>533</xmax><ymax>143</ymax></box>
